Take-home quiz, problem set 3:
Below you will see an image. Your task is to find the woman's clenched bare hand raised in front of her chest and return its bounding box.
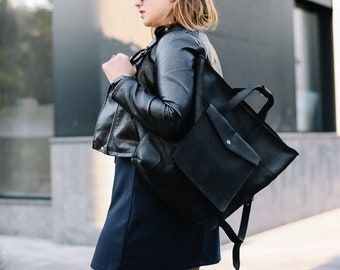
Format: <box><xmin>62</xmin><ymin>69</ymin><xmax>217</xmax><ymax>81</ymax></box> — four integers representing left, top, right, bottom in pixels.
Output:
<box><xmin>102</xmin><ymin>53</ymin><xmax>137</xmax><ymax>83</ymax></box>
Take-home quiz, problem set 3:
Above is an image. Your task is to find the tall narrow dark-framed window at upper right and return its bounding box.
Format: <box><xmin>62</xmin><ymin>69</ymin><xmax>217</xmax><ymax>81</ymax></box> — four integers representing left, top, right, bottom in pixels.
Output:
<box><xmin>294</xmin><ymin>1</ymin><xmax>335</xmax><ymax>132</ymax></box>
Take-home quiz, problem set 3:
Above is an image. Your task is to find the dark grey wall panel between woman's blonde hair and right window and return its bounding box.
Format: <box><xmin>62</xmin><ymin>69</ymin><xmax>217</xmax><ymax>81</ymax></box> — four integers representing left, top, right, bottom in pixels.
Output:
<box><xmin>209</xmin><ymin>0</ymin><xmax>296</xmax><ymax>131</ymax></box>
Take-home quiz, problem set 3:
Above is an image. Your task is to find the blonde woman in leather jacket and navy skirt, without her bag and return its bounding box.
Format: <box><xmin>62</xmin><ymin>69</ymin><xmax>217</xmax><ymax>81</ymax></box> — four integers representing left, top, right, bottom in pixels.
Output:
<box><xmin>91</xmin><ymin>0</ymin><xmax>220</xmax><ymax>270</ymax></box>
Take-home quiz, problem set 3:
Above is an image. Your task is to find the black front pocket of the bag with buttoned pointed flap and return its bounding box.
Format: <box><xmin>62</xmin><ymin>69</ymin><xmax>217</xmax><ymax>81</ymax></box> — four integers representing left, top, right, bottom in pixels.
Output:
<box><xmin>173</xmin><ymin>104</ymin><xmax>260</xmax><ymax>212</ymax></box>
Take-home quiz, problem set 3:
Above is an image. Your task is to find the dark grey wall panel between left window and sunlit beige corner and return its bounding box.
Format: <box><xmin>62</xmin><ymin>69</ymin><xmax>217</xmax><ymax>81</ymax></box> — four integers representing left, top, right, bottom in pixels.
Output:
<box><xmin>53</xmin><ymin>0</ymin><xmax>100</xmax><ymax>137</ymax></box>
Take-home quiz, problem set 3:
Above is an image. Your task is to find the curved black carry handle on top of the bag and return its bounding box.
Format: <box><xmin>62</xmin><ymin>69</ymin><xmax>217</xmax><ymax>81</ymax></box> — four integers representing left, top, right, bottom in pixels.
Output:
<box><xmin>219</xmin><ymin>84</ymin><xmax>274</xmax><ymax>122</ymax></box>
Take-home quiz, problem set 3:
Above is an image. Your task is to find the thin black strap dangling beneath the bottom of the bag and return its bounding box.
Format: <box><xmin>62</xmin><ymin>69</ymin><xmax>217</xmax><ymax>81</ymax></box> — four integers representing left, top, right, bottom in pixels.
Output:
<box><xmin>219</xmin><ymin>200</ymin><xmax>253</xmax><ymax>270</ymax></box>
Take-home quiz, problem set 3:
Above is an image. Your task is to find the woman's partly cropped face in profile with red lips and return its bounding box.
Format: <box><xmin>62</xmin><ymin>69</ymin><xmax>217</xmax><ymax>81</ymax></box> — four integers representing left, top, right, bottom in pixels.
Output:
<box><xmin>135</xmin><ymin>0</ymin><xmax>174</xmax><ymax>27</ymax></box>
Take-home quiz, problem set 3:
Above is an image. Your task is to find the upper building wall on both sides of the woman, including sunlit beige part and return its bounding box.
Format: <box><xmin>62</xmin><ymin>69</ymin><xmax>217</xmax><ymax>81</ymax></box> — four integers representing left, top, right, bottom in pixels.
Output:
<box><xmin>53</xmin><ymin>0</ymin><xmax>296</xmax><ymax>137</ymax></box>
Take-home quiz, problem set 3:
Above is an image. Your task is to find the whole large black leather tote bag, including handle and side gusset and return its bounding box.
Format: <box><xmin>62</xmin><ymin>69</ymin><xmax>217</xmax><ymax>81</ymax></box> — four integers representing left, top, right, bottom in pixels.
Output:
<box><xmin>132</xmin><ymin>56</ymin><xmax>297</xmax><ymax>229</ymax></box>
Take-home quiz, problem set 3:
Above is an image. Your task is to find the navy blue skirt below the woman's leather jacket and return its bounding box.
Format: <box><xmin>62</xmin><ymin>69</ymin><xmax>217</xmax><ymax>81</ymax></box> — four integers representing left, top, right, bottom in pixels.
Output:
<box><xmin>91</xmin><ymin>158</ymin><xmax>220</xmax><ymax>270</ymax></box>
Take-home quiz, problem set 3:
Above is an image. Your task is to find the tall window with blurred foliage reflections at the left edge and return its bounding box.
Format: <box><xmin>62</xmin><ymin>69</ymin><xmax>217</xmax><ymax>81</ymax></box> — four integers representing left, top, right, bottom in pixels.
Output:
<box><xmin>0</xmin><ymin>0</ymin><xmax>54</xmax><ymax>198</ymax></box>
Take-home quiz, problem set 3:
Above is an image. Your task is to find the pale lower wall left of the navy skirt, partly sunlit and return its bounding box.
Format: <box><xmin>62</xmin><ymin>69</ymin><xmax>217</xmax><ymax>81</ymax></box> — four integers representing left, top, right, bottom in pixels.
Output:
<box><xmin>51</xmin><ymin>137</ymin><xmax>114</xmax><ymax>244</ymax></box>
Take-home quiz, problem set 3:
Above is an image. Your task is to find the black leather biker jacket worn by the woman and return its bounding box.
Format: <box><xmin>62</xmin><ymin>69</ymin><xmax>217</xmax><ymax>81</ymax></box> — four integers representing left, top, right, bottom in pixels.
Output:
<box><xmin>93</xmin><ymin>25</ymin><xmax>221</xmax><ymax>157</ymax></box>
